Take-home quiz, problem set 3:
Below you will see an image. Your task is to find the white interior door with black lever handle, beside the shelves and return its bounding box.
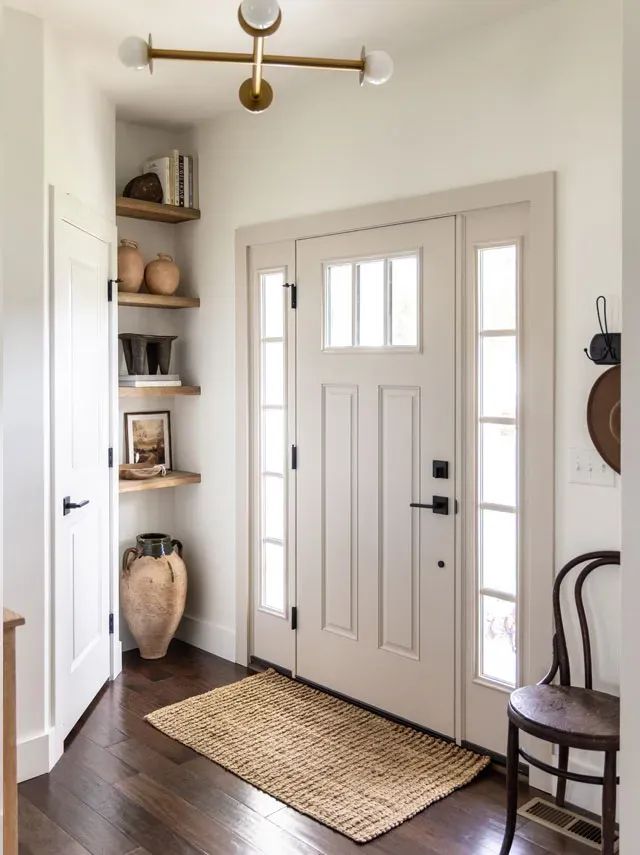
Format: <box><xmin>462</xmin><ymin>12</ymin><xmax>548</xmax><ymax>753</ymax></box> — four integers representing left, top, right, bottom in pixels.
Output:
<box><xmin>52</xmin><ymin>199</ymin><xmax>115</xmax><ymax>739</ymax></box>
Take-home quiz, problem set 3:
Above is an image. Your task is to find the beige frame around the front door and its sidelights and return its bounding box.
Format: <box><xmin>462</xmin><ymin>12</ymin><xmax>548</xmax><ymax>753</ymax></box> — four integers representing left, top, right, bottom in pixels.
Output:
<box><xmin>235</xmin><ymin>172</ymin><xmax>556</xmax><ymax>764</ymax></box>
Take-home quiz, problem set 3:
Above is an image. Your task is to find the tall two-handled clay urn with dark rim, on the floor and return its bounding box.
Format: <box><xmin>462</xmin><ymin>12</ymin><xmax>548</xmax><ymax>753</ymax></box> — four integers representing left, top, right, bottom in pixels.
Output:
<box><xmin>120</xmin><ymin>534</ymin><xmax>187</xmax><ymax>659</ymax></box>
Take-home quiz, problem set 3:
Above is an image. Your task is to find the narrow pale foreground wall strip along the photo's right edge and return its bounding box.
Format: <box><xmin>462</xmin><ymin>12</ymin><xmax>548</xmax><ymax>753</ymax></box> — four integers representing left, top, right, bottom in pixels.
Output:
<box><xmin>620</xmin><ymin>0</ymin><xmax>640</xmax><ymax>852</ymax></box>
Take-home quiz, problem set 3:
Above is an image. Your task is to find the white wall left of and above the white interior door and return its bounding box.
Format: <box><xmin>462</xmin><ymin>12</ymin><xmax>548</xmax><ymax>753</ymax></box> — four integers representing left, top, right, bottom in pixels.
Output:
<box><xmin>3</xmin><ymin>9</ymin><xmax>114</xmax><ymax>778</ymax></box>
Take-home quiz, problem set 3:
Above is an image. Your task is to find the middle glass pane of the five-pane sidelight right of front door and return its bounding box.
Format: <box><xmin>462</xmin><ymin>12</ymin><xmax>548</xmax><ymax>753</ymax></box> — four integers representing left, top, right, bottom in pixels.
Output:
<box><xmin>480</xmin><ymin>424</ymin><xmax>516</xmax><ymax>507</ymax></box>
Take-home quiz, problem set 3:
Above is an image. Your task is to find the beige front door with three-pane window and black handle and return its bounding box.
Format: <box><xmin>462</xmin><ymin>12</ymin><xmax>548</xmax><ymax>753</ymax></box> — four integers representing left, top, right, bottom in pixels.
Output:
<box><xmin>296</xmin><ymin>217</ymin><xmax>456</xmax><ymax>735</ymax></box>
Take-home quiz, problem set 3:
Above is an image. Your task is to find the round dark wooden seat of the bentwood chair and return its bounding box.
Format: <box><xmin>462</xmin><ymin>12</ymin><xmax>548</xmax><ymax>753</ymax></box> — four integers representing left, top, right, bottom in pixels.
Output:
<box><xmin>509</xmin><ymin>685</ymin><xmax>620</xmax><ymax>751</ymax></box>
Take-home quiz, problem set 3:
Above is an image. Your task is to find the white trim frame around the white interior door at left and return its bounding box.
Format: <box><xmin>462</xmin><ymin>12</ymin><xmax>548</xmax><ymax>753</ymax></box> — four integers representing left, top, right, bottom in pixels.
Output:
<box><xmin>48</xmin><ymin>185</ymin><xmax>122</xmax><ymax>768</ymax></box>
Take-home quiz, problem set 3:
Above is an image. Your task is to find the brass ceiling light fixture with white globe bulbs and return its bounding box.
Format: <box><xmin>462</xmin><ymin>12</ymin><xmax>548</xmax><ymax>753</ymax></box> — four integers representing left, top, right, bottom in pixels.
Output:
<box><xmin>119</xmin><ymin>0</ymin><xmax>393</xmax><ymax>113</ymax></box>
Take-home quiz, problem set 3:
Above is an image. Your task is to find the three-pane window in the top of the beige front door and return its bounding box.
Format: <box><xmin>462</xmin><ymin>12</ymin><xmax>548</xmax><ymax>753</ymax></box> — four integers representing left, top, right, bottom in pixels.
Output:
<box><xmin>323</xmin><ymin>252</ymin><xmax>420</xmax><ymax>350</ymax></box>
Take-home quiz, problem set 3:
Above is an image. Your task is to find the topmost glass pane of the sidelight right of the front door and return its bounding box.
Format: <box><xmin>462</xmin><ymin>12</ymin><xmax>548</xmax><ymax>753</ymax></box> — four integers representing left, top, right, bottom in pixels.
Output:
<box><xmin>478</xmin><ymin>244</ymin><xmax>518</xmax><ymax>330</ymax></box>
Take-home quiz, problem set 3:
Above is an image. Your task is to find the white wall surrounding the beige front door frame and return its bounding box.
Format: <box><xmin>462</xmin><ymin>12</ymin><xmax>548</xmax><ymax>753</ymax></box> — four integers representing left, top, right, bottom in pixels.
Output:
<box><xmin>176</xmin><ymin>0</ymin><xmax>621</xmax><ymax>804</ymax></box>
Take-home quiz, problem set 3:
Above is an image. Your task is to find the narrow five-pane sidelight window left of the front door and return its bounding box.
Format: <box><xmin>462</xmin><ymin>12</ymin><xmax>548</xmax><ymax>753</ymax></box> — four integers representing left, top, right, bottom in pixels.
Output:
<box><xmin>258</xmin><ymin>269</ymin><xmax>287</xmax><ymax>617</ymax></box>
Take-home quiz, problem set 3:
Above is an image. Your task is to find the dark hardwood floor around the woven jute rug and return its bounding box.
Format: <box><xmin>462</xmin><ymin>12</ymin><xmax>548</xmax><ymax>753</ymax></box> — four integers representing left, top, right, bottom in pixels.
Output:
<box><xmin>20</xmin><ymin>641</ymin><xmax>593</xmax><ymax>855</ymax></box>
